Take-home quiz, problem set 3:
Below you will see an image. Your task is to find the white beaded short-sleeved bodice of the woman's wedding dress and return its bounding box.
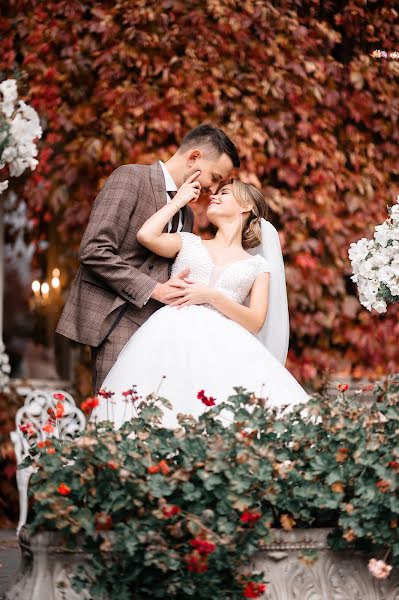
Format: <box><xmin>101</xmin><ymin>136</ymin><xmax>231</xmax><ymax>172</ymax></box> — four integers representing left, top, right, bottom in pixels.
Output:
<box><xmin>172</xmin><ymin>231</ymin><xmax>270</xmax><ymax>304</ymax></box>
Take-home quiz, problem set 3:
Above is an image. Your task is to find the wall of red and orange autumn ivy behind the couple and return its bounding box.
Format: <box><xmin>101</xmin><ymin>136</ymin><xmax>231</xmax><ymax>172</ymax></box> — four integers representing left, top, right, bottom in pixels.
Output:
<box><xmin>0</xmin><ymin>0</ymin><xmax>399</xmax><ymax>381</ymax></box>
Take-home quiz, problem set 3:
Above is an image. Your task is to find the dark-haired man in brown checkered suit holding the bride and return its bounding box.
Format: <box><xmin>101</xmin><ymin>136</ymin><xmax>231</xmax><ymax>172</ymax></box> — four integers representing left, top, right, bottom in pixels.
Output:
<box><xmin>56</xmin><ymin>124</ymin><xmax>240</xmax><ymax>393</ymax></box>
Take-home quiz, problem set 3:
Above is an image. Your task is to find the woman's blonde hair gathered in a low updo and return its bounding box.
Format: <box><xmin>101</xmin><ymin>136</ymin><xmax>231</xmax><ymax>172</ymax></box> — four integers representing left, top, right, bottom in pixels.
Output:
<box><xmin>230</xmin><ymin>179</ymin><xmax>267</xmax><ymax>250</ymax></box>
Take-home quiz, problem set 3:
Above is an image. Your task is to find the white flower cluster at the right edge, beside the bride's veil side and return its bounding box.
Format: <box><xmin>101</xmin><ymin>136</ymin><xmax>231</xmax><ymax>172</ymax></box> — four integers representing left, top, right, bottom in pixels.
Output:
<box><xmin>348</xmin><ymin>195</ymin><xmax>399</xmax><ymax>313</ymax></box>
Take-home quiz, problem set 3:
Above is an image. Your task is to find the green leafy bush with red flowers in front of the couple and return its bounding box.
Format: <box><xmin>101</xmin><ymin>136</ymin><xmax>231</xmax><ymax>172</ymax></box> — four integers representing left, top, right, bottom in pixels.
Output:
<box><xmin>26</xmin><ymin>377</ymin><xmax>399</xmax><ymax>600</ymax></box>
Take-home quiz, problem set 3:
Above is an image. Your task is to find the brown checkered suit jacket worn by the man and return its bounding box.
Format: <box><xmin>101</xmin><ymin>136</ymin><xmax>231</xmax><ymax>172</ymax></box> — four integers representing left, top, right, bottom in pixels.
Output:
<box><xmin>56</xmin><ymin>162</ymin><xmax>194</xmax><ymax>347</ymax></box>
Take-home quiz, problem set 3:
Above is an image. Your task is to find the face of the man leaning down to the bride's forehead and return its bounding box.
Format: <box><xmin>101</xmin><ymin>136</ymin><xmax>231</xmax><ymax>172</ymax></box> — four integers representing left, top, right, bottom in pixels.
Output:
<box><xmin>184</xmin><ymin>150</ymin><xmax>233</xmax><ymax>194</ymax></box>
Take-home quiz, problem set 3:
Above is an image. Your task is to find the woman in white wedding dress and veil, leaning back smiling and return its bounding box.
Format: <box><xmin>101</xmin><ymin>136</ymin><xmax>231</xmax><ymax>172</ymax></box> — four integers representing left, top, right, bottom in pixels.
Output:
<box><xmin>91</xmin><ymin>172</ymin><xmax>309</xmax><ymax>427</ymax></box>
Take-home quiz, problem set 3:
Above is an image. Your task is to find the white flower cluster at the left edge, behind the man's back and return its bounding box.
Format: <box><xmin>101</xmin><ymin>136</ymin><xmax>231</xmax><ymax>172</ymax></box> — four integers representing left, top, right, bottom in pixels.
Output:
<box><xmin>0</xmin><ymin>79</ymin><xmax>43</xmax><ymax>194</ymax></box>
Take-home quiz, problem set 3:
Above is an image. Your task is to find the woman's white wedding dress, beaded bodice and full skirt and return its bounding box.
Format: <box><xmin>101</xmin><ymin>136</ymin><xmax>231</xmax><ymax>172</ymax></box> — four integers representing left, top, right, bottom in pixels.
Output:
<box><xmin>91</xmin><ymin>232</ymin><xmax>309</xmax><ymax>427</ymax></box>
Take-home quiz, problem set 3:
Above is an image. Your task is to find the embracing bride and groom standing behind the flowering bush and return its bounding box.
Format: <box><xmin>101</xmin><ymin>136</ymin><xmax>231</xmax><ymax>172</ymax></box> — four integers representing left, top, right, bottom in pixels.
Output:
<box><xmin>57</xmin><ymin>124</ymin><xmax>308</xmax><ymax>427</ymax></box>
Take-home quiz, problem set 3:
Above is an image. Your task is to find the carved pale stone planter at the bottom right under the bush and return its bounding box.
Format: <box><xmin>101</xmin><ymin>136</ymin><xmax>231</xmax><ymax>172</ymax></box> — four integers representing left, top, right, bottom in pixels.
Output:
<box><xmin>254</xmin><ymin>529</ymin><xmax>399</xmax><ymax>600</ymax></box>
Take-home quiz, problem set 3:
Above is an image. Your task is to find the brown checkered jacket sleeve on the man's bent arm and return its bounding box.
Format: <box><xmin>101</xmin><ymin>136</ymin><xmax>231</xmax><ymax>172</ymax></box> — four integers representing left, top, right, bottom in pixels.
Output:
<box><xmin>79</xmin><ymin>165</ymin><xmax>158</xmax><ymax>308</ymax></box>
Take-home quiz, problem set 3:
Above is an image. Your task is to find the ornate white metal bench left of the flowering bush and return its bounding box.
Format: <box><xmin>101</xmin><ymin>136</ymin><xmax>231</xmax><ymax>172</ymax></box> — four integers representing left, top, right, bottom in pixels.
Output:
<box><xmin>10</xmin><ymin>389</ymin><xmax>86</xmax><ymax>535</ymax></box>
